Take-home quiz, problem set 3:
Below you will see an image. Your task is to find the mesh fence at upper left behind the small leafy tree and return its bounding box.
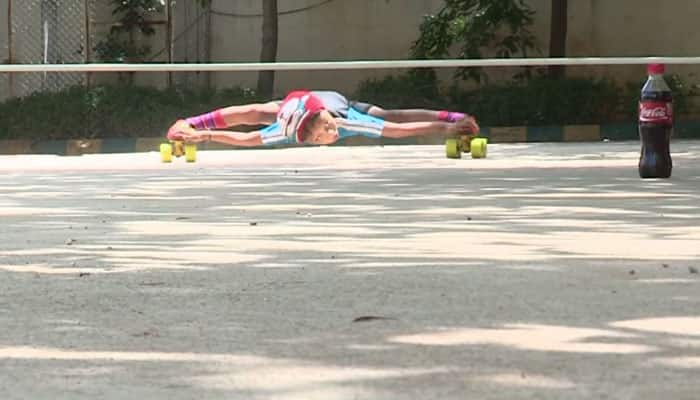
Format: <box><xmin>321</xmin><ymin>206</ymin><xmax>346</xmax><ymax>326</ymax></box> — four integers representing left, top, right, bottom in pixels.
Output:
<box><xmin>0</xmin><ymin>0</ymin><xmax>211</xmax><ymax>100</ymax></box>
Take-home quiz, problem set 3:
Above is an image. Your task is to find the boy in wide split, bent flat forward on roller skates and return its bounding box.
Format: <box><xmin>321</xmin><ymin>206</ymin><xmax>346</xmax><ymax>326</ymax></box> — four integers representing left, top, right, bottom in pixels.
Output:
<box><xmin>168</xmin><ymin>90</ymin><xmax>479</xmax><ymax>147</ymax></box>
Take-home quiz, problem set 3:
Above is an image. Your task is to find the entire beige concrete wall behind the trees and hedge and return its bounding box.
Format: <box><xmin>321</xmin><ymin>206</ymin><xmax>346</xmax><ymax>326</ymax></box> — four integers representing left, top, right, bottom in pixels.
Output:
<box><xmin>0</xmin><ymin>0</ymin><xmax>700</xmax><ymax>98</ymax></box>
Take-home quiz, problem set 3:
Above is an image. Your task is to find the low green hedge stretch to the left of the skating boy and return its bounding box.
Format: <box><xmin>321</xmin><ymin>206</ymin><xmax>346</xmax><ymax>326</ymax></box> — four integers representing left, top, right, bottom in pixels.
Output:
<box><xmin>0</xmin><ymin>85</ymin><xmax>258</xmax><ymax>140</ymax></box>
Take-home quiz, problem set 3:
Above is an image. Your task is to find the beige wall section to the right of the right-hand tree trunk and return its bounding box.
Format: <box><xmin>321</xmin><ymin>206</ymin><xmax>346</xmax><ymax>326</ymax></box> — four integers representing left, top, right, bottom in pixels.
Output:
<box><xmin>567</xmin><ymin>0</ymin><xmax>700</xmax><ymax>81</ymax></box>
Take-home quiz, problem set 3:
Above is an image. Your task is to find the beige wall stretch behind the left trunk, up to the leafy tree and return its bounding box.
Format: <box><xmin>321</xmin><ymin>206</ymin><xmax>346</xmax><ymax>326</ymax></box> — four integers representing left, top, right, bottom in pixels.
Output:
<box><xmin>205</xmin><ymin>0</ymin><xmax>442</xmax><ymax>93</ymax></box>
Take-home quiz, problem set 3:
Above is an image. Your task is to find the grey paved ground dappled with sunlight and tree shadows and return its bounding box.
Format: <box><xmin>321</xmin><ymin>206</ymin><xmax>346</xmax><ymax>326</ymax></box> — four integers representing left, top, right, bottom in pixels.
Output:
<box><xmin>0</xmin><ymin>142</ymin><xmax>700</xmax><ymax>400</ymax></box>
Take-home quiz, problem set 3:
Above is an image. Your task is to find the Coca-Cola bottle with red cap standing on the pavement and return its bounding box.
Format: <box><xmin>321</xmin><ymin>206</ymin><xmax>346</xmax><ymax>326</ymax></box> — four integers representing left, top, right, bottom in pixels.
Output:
<box><xmin>639</xmin><ymin>64</ymin><xmax>673</xmax><ymax>178</ymax></box>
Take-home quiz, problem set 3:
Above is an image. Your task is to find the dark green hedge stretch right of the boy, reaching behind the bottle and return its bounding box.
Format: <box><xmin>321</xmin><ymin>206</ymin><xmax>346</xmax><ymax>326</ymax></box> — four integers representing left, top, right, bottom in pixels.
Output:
<box><xmin>356</xmin><ymin>72</ymin><xmax>689</xmax><ymax>126</ymax></box>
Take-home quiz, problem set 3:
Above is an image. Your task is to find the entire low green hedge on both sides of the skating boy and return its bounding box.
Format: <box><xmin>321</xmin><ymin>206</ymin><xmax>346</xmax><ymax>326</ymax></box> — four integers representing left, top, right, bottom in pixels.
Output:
<box><xmin>0</xmin><ymin>70</ymin><xmax>688</xmax><ymax>140</ymax></box>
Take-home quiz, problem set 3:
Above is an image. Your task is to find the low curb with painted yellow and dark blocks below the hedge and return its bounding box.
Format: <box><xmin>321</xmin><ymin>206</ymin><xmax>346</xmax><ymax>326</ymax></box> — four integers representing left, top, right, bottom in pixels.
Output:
<box><xmin>0</xmin><ymin>121</ymin><xmax>700</xmax><ymax>156</ymax></box>
